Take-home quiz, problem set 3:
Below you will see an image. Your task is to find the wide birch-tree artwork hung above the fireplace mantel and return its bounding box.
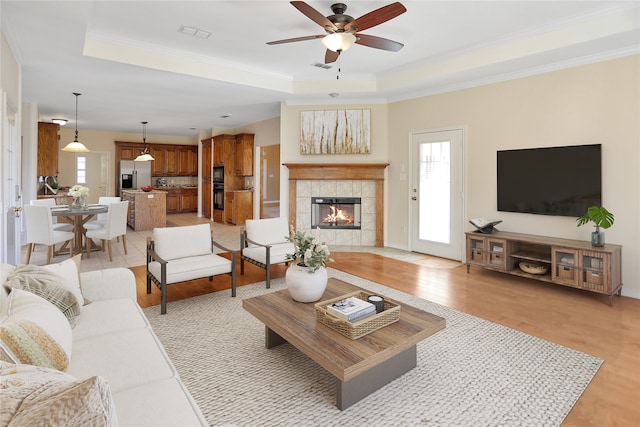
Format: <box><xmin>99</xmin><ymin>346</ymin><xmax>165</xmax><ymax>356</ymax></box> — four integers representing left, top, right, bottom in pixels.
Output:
<box><xmin>300</xmin><ymin>109</ymin><xmax>371</xmax><ymax>154</ymax></box>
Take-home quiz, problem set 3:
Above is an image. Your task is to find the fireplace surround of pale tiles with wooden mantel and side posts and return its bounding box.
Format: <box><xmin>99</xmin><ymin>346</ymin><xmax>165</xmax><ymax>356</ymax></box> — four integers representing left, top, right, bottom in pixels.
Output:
<box><xmin>284</xmin><ymin>163</ymin><xmax>389</xmax><ymax>247</ymax></box>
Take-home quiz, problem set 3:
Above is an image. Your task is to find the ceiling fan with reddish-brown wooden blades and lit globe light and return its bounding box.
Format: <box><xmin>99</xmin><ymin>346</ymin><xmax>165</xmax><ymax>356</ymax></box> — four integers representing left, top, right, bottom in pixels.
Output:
<box><xmin>267</xmin><ymin>1</ymin><xmax>407</xmax><ymax>64</ymax></box>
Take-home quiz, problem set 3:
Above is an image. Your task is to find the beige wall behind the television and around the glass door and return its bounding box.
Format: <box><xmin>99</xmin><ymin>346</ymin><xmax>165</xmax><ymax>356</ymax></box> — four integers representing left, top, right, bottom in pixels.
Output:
<box><xmin>385</xmin><ymin>56</ymin><xmax>640</xmax><ymax>298</ymax></box>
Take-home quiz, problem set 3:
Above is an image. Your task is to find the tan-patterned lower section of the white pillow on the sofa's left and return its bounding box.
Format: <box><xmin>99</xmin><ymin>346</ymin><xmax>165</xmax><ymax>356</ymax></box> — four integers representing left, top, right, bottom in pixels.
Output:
<box><xmin>0</xmin><ymin>320</ymin><xmax>69</xmax><ymax>371</ymax></box>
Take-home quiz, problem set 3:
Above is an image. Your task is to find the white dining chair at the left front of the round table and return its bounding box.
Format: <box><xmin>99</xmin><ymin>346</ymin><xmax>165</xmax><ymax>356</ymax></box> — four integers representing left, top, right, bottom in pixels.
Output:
<box><xmin>23</xmin><ymin>205</ymin><xmax>75</xmax><ymax>264</ymax></box>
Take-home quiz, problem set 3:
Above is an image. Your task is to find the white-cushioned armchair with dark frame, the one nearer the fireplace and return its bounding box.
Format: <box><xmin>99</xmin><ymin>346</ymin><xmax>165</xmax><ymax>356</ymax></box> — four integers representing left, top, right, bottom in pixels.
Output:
<box><xmin>240</xmin><ymin>217</ymin><xmax>295</xmax><ymax>288</ymax></box>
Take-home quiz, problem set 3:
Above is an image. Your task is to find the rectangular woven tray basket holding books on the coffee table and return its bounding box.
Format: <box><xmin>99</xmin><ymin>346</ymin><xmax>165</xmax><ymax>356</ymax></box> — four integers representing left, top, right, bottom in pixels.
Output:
<box><xmin>315</xmin><ymin>291</ymin><xmax>400</xmax><ymax>340</ymax></box>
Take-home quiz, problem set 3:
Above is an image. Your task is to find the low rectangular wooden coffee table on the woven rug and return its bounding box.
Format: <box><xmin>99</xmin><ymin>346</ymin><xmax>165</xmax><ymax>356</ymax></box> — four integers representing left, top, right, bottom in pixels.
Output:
<box><xmin>242</xmin><ymin>278</ymin><xmax>446</xmax><ymax>409</ymax></box>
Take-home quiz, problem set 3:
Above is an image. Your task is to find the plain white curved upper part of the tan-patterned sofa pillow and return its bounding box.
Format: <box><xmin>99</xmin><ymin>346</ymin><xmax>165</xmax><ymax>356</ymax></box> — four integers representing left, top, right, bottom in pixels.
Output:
<box><xmin>0</xmin><ymin>289</ymin><xmax>72</xmax><ymax>372</ymax></box>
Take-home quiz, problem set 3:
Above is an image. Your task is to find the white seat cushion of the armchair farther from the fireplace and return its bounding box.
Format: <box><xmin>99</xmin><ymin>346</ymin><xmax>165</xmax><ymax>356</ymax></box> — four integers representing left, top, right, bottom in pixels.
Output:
<box><xmin>149</xmin><ymin>254</ymin><xmax>232</xmax><ymax>284</ymax></box>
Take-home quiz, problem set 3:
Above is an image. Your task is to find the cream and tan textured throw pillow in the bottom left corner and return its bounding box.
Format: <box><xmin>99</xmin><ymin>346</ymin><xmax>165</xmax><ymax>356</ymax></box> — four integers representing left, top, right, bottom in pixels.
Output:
<box><xmin>0</xmin><ymin>362</ymin><xmax>118</xmax><ymax>427</ymax></box>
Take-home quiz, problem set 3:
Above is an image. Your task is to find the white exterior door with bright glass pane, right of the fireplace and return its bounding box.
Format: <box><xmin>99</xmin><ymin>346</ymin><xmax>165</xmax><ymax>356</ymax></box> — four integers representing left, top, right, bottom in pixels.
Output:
<box><xmin>410</xmin><ymin>129</ymin><xmax>464</xmax><ymax>260</ymax></box>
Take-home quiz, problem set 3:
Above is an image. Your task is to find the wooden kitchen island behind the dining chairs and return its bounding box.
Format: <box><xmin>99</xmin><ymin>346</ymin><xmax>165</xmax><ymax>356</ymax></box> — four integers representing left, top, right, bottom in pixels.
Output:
<box><xmin>122</xmin><ymin>190</ymin><xmax>167</xmax><ymax>231</ymax></box>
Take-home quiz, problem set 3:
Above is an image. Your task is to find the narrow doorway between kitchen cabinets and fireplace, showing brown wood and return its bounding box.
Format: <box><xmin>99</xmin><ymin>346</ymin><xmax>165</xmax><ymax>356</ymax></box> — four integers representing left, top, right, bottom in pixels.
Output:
<box><xmin>260</xmin><ymin>144</ymin><xmax>280</xmax><ymax>218</ymax></box>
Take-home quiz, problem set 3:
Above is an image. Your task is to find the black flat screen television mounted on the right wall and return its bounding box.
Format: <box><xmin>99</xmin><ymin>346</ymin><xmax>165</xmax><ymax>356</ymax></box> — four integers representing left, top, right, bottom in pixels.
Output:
<box><xmin>497</xmin><ymin>144</ymin><xmax>602</xmax><ymax>217</ymax></box>
